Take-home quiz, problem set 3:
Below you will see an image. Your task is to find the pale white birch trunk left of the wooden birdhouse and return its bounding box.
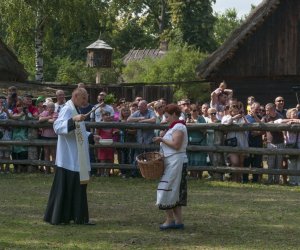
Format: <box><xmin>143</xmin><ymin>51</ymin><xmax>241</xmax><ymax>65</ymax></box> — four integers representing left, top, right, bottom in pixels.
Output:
<box><xmin>35</xmin><ymin>0</ymin><xmax>44</xmax><ymax>82</ymax></box>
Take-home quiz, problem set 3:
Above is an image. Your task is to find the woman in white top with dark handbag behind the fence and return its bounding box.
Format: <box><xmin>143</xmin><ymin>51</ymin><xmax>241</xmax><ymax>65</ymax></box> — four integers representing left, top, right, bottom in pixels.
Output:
<box><xmin>222</xmin><ymin>106</ymin><xmax>248</xmax><ymax>182</ymax></box>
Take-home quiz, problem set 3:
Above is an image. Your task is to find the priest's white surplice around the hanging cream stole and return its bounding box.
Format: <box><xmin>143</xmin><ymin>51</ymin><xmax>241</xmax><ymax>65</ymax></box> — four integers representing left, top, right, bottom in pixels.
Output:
<box><xmin>53</xmin><ymin>100</ymin><xmax>91</xmax><ymax>176</ymax></box>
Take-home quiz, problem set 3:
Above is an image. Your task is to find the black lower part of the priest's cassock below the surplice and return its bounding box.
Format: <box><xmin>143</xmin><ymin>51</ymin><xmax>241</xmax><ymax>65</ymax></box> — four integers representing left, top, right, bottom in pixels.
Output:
<box><xmin>44</xmin><ymin>167</ymin><xmax>89</xmax><ymax>224</ymax></box>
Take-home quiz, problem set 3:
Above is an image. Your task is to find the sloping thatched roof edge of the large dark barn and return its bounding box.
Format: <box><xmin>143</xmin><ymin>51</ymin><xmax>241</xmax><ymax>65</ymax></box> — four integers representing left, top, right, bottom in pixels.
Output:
<box><xmin>196</xmin><ymin>0</ymin><xmax>280</xmax><ymax>80</ymax></box>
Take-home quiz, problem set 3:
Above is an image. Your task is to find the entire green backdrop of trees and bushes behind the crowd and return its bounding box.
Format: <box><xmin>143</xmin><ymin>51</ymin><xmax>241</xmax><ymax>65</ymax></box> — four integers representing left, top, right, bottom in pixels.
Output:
<box><xmin>0</xmin><ymin>0</ymin><xmax>242</xmax><ymax>99</ymax></box>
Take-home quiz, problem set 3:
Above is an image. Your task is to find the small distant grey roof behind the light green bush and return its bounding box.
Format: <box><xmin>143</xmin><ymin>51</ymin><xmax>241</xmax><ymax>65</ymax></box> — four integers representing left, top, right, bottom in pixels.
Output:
<box><xmin>123</xmin><ymin>49</ymin><xmax>167</xmax><ymax>64</ymax></box>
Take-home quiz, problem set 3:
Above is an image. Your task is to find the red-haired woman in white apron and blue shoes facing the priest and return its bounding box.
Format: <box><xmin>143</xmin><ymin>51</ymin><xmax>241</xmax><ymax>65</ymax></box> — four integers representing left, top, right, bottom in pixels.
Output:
<box><xmin>153</xmin><ymin>104</ymin><xmax>188</xmax><ymax>230</ymax></box>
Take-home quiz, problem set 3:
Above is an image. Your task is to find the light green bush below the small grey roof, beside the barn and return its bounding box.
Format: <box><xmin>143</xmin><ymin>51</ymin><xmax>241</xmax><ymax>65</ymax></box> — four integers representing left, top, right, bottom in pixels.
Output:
<box><xmin>123</xmin><ymin>46</ymin><xmax>209</xmax><ymax>101</ymax></box>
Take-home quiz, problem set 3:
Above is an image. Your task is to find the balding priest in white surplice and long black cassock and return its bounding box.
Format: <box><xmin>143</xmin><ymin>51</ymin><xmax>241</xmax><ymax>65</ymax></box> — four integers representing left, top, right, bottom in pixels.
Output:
<box><xmin>44</xmin><ymin>88</ymin><xmax>98</xmax><ymax>225</ymax></box>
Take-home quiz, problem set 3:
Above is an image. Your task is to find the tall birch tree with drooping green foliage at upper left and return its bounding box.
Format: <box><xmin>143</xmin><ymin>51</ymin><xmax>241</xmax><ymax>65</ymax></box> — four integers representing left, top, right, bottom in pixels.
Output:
<box><xmin>0</xmin><ymin>0</ymin><xmax>108</xmax><ymax>80</ymax></box>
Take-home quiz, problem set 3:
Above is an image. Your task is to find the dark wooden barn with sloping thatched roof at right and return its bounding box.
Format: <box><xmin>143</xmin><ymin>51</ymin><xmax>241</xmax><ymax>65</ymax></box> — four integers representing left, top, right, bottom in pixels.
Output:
<box><xmin>196</xmin><ymin>0</ymin><xmax>300</xmax><ymax>107</ymax></box>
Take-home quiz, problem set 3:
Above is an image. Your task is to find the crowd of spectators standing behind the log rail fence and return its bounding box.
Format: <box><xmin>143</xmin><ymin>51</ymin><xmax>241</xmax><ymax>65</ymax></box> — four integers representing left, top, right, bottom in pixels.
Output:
<box><xmin>0</xmin><ymin>82</ymin><xmax>300</xmax><ymax>185</ymax></box>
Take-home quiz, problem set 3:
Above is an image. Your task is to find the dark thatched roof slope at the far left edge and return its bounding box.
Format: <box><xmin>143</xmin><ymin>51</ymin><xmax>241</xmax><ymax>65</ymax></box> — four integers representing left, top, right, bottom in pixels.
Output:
<box><xmin>0</xmin><ymin>39</ymin><xmax>28</xmax><ymax>81</ymax></box>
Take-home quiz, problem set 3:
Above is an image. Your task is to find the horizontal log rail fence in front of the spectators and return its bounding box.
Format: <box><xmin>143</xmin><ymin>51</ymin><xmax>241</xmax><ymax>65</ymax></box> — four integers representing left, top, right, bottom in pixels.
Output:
<box><xmin>0</xmin><ymin>120</ymin><xmax>300</xmax><ymax>176</ymax></box>
